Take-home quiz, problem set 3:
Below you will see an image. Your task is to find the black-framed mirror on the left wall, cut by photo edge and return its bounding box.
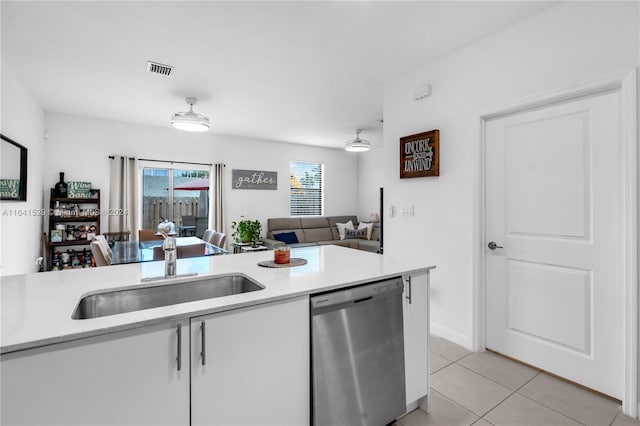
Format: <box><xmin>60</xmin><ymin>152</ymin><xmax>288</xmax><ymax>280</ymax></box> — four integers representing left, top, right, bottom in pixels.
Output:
<box><xmin>0</xmin><ymin>134</ymin><xmax>27</xmax><ymax>201</ymax></box>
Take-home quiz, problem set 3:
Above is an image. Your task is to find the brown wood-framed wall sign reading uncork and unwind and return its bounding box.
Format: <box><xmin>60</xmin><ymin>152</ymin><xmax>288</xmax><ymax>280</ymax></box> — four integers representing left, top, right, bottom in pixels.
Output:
<box><xmin>400</xmin><ymin>129</ymin><xmax>440</xmax><ymax>179</ymax></box>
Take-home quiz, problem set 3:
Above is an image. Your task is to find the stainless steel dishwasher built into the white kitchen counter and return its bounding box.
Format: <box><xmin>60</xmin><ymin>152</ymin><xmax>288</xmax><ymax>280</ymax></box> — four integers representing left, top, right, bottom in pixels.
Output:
<box><xmin>311</xmin><ymin>277</ymin><xmax>406</xmax><ymax>426</ymax></box>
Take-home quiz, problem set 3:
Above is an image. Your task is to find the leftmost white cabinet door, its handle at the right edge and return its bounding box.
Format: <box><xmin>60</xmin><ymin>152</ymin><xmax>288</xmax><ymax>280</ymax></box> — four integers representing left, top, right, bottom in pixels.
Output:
<box><xmin>0</xmin><ymin>321</ymin><xmax>189</xmax><ymax>425</ymax></box>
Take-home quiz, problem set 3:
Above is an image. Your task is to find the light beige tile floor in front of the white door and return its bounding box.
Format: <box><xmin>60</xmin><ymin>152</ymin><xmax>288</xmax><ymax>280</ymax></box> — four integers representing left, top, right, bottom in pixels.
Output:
<box><xmin>397</xmin><ymin>336</ymin><xmax>640</xmax><ymax>426</ymax></box>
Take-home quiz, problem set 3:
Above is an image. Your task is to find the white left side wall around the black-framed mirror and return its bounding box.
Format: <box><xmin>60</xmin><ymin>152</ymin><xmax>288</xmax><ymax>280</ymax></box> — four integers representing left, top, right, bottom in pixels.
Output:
<box><xmin>0</xmin><ymin>61</ymin><xmax>44</xmax><ymax>275</ymax></box>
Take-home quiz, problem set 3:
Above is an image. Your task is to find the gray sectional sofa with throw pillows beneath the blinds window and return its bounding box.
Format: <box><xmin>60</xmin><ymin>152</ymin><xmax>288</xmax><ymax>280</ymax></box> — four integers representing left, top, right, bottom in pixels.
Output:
<box><xmin>263</xmin><ymin>216</ymin><xmax>380</xmax><ymax>253</ymax></box>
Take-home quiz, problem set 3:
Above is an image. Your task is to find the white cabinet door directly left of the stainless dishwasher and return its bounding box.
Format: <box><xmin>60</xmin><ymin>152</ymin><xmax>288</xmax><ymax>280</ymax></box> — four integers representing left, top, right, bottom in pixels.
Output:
<box><xmin>191</xmin><ymin>296</ymin><xmax>310</xmax><ymax>426</ymax></box>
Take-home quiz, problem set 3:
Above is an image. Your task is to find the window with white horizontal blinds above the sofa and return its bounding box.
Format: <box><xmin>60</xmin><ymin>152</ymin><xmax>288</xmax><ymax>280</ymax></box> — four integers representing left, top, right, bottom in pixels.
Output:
<box><xmin>290</xmin><ymin>161</ymin><xmax>324</xmax><ymax>216</ymax></box>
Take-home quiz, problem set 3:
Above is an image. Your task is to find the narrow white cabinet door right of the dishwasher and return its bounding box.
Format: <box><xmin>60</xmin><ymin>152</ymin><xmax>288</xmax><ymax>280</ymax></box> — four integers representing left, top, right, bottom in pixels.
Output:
<box><xmin>403</xmin><ymin>272</ymin><xmax>429</xmax><ymax>411</ymax></box>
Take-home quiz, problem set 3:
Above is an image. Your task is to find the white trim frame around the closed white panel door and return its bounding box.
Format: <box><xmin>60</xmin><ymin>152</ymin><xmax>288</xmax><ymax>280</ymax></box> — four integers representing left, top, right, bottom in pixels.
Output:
<box><xmin>472</xmin><ymin>68</ymin><xmax>640</xmax><ymax>418</ymax></box>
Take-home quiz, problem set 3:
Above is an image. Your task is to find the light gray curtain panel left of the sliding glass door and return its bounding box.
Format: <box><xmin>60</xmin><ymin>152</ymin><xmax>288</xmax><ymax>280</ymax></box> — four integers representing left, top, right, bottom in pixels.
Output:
<box><xmin>108</xmin><ymin>155</ymin><xmax>141</xmax><ymax>235</ymax></box>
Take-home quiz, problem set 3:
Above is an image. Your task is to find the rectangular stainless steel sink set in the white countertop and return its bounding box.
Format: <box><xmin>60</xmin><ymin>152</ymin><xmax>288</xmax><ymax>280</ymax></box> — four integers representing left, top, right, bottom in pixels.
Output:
<box><xmin>71</xmin><ymin>275</ymin><xmax>264</xmax><ymax>319</ymax></box>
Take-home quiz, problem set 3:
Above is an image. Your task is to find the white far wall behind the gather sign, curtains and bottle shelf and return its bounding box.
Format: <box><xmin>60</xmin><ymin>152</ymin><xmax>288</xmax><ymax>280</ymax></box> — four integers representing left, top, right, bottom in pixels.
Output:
<box><xmin>44</xmin><ymin>113</ymin><xmax>358</xmax><ymax>243</ymax></box>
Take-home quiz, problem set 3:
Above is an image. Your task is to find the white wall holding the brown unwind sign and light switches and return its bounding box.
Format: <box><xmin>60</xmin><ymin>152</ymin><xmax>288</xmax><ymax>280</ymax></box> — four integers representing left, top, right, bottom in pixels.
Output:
<box><xmin>360</xmin><ymin>2</ymin><xmax>639</xmax><ymax>347</ymax></box>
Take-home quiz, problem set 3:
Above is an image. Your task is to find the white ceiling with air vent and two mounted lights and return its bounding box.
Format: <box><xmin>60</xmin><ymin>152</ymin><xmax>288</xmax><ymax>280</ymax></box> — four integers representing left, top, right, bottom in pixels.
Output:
<box><xmin>0</xmin><ymin>1</ymin><xmax>551</xmax><ymax>147</ymax></box>
